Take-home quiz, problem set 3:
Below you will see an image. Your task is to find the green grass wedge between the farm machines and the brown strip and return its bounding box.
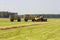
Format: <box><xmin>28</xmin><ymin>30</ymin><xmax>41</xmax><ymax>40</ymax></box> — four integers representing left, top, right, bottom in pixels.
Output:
<box><xmin>0</xmin><ymin>18</ymin><xmax>33</xmax><ymax>27</ymax></box>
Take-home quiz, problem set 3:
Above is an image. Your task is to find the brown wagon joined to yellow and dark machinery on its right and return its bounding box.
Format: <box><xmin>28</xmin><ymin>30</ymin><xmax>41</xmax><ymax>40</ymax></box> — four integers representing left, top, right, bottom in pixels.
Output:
<box><xmin>24</xmin><ymin>14</ymin><xmax>47</xmax><ymax>22</ymax></box>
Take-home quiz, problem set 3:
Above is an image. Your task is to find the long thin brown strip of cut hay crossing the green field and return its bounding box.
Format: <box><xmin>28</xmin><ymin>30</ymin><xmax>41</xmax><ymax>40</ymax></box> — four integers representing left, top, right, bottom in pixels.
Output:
<box><xmin>0</xmin><ymin>22</ymin><xmax>47</xmax><ymax>30</ymax></box>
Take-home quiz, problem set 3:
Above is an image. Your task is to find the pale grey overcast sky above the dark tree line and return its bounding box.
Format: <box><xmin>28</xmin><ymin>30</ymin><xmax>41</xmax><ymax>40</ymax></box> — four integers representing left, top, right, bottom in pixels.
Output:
<box><xmin>0</xmin><ymin>0</ymin><xmax>60</xmax><ymax>14</ymax></box>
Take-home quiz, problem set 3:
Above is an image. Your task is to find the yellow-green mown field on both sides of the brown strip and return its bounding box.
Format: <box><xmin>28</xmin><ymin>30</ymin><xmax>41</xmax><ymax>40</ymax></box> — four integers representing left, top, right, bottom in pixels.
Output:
<box><xmin>0</xmin><ymin>18</ymin><xmax>60</xmax><ymax>40</ymax></box>
